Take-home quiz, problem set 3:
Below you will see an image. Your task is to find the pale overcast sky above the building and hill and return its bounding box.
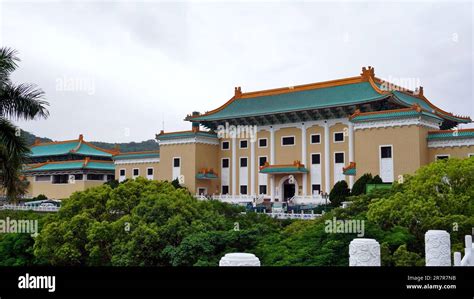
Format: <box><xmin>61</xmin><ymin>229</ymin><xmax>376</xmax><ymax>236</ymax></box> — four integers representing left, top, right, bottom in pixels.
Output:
<box><xmin>0</xmin><ymin>1</ymin><xmax>474</xmax><ymax>142</ymax></box>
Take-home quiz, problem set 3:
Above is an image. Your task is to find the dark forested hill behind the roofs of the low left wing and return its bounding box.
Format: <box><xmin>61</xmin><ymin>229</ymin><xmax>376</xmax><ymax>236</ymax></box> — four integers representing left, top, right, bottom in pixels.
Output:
<box><xmin>21</xmin><ymin>130</ymin><xmax>160</xmax><ymax>152</ymax></box>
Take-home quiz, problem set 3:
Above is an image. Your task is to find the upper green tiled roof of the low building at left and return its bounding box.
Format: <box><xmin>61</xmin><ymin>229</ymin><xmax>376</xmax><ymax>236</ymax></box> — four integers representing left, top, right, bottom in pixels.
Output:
<box><xmin>30</xmin><ymin>140</ymin><xmax>112</xmax><ymax>157</ymax></box>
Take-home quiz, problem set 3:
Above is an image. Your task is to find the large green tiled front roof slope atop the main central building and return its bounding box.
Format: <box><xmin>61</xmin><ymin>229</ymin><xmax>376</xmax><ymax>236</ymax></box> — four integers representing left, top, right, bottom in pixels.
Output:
<box><xmin>193</xmin><ymin>82</ymin><xmax>387</xmax><ymax>121</ymax></box>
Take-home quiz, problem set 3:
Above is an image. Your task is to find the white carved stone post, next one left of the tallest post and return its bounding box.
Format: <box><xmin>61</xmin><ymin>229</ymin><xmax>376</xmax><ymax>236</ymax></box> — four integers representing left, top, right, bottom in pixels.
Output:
<box><xmin>349</xmin><ymin>238</ymin><xmax>381</xmax><ymax>266</ymax></box>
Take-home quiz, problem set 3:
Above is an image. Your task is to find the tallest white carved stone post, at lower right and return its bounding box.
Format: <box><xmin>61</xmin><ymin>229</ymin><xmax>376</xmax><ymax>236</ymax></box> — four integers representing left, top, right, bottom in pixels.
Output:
<box><xmin>425</xmin><ymin>230</ymin><xmax>451</xmax><ymax>266</ymax></box>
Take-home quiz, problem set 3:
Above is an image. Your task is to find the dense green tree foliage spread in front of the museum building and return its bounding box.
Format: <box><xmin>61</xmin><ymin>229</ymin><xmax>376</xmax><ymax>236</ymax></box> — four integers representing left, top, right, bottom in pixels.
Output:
<box><xmin>0</xmin><ymin>158</ymin><xmax>474</xmax><ymax>266</ymax></box>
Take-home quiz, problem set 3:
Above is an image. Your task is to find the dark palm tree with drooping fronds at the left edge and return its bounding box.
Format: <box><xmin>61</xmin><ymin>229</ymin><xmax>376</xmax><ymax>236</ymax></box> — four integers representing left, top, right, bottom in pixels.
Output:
<box><xmin>0</xmin><ymin>48</ymin><xmax>49</xmax><ymax>199</ymax></box>
